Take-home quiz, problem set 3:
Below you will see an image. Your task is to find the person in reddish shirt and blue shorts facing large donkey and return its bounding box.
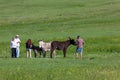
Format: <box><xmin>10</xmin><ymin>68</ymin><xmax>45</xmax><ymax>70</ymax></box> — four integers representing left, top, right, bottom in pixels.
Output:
<box><xmin>76</xmin><ymin>36</ymin><xmax>84</xmax><ymax>60</ymax></box>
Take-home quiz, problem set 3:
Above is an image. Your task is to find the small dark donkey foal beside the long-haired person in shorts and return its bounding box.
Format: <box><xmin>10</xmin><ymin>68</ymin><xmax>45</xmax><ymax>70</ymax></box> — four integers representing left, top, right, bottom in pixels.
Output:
<box><xmin>31</xmin><ymin>44</ymin><xmax>46</xmax><ymax>58</ymax></box>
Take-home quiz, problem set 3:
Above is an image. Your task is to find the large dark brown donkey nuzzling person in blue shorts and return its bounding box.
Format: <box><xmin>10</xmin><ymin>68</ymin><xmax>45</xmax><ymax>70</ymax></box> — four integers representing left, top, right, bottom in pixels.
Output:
<box><xmin>50</xmin><ymin>38</ymin><xmax>76</xmax><ymax>58</ymax></box>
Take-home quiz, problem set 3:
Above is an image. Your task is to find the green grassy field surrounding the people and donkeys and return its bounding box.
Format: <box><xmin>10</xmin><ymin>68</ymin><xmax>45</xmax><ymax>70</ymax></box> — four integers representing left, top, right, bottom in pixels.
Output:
<box><xmin>0</xmin><ymin>0</ymin><xmax>120</xmax><ymax>80</ymax></box>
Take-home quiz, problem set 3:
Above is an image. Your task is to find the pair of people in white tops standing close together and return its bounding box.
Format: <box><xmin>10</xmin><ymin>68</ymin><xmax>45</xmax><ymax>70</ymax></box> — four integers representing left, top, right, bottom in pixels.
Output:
<box><xmin>10</xmin><ymin>35</ymin><xmax>21</xmax><ymax>58</ymax></box>
